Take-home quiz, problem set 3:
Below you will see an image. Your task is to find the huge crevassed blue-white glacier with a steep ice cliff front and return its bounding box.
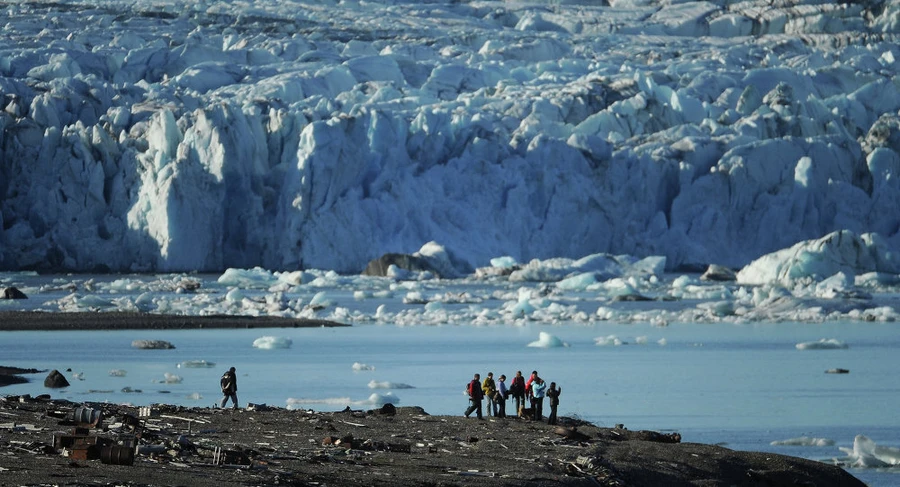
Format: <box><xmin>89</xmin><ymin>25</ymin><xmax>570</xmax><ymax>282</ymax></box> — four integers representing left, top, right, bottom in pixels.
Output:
<box><xmin>0</xmin><ymin>0</ymin><xmax>900</xmax><ymax>274</ymax></box>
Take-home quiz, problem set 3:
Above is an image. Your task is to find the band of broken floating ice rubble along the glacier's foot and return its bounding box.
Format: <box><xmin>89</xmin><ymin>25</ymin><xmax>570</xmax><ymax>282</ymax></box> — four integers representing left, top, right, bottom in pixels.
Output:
<box><xmin>12</xmin><ymin>231</ymin><xmax>900</xmax><ymax>326</ymax></box>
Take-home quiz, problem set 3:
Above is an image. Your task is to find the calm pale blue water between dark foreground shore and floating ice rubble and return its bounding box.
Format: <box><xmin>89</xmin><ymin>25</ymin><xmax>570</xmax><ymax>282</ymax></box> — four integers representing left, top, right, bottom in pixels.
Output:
<box><xmin>0</xmin><ymin>323</ymin><xmax>900</xmax><ymax>485</ymax></box>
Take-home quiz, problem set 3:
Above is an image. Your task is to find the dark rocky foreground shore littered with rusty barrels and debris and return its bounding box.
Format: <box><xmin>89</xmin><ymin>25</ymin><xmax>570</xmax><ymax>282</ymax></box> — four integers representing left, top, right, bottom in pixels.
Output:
<box><xmin>0</xmin><ymin>396</ymin><xmax>864</xmax><ymax>487</ymax></box>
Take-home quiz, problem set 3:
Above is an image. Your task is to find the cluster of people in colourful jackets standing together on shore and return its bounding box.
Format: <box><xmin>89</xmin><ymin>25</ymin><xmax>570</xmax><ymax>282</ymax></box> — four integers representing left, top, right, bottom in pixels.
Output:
<box><xmin>465</xmin><ymin>370</ymin><xmax>562</xmax><ymax>424</ymax></box>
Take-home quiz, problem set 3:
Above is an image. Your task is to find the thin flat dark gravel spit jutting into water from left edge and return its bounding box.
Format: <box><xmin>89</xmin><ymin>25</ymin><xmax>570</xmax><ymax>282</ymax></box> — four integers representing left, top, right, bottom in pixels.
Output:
<box><xmin>0</xmin><ymin>311</ymin><xmax>351</xmax><ymax>331</ymax></box>
